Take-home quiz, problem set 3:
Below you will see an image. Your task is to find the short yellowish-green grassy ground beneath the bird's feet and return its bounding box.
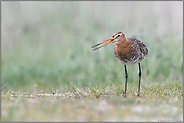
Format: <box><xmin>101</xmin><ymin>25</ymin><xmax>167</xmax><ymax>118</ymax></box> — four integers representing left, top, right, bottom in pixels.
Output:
<box><xmin>2</xmin><ymin>83</ymin><xmax>183</xmax><ymax>122</ymax></box>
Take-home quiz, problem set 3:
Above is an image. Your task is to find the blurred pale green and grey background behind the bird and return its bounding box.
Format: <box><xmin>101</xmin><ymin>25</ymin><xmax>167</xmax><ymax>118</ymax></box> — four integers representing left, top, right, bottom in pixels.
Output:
<box><xmin>1</xmin><ymin>1</ymin><xmax>183</xmax><ymax>91</ymax></box>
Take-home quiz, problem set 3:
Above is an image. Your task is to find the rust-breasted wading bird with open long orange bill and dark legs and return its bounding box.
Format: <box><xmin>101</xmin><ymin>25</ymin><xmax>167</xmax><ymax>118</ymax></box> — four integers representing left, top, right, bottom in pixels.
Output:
<box><xmin>92</xmin><ymin>32</ymin><xmax>148</xmax><ymax>97</ymax></box>
